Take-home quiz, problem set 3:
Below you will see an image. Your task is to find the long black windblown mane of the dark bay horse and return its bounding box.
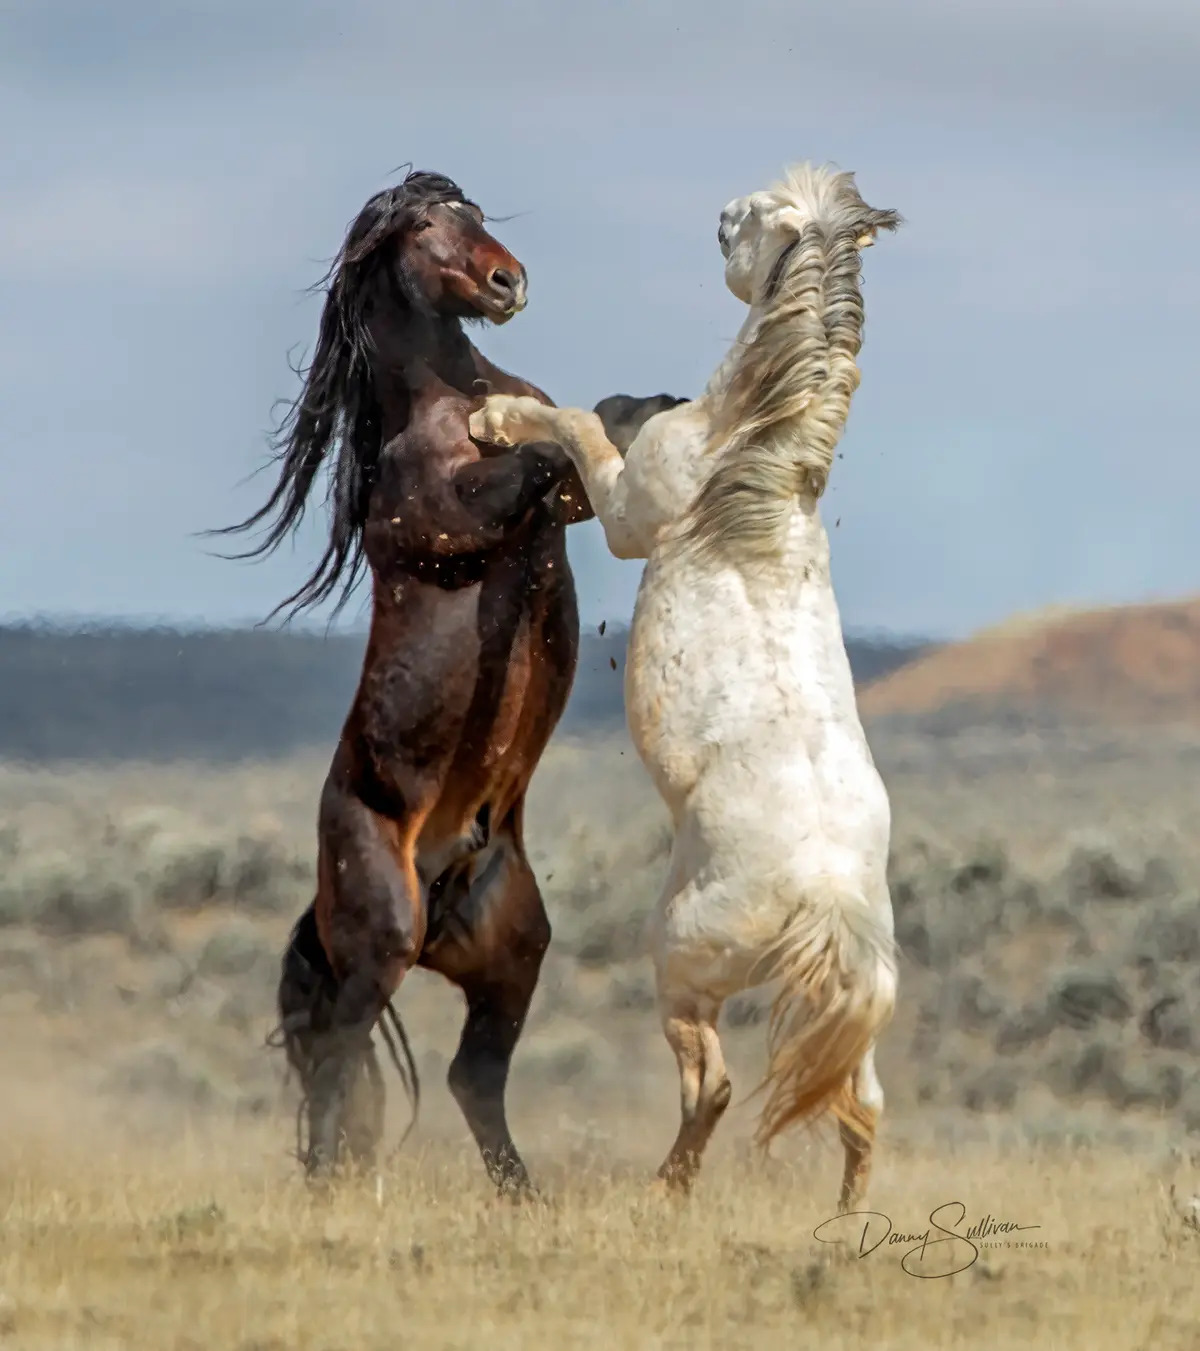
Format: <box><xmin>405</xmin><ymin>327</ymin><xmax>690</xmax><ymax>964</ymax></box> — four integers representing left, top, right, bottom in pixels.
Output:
<box><xmin>208</xmin><ymin>170</ymin><xmax>474</xmax><ymax>617</ymax></box>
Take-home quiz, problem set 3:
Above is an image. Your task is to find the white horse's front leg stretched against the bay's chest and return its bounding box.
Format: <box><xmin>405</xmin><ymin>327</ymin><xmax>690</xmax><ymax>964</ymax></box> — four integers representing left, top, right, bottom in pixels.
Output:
<box><xmin>470</xmin><ymin>394</ymin><xmax>649</xmax><ymax>558</ymax></box>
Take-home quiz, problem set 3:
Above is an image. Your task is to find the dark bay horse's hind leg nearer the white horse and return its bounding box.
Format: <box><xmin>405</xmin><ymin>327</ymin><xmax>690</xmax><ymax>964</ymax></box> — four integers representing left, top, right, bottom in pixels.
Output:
<box><xmin>420</xmin><ymin>828</ymin><xmax>550</xmax><ymax>1194</ymax></box>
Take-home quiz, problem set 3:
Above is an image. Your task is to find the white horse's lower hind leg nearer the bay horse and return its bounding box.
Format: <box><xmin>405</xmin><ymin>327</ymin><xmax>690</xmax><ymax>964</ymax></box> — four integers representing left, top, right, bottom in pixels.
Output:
<box><xmin>658</xmin><ymin>996</ymin><xmax>732</xmax><ymax>1192</ymax></box>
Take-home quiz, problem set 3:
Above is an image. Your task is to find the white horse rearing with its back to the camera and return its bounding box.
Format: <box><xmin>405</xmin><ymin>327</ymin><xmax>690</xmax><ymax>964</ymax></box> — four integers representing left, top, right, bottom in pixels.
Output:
<box><xmin>470</xmin><ymin>165</ymin><xmax>900</xmax><ymax>1209</ymax></box>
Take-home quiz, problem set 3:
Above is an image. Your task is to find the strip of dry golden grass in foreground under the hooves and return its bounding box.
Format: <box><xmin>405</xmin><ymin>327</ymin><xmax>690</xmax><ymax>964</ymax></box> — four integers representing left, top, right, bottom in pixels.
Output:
<box><xmin>7</xmin><ymin>1107</ymin><xmax>1200</xmax><ymax>1351</ymax></box>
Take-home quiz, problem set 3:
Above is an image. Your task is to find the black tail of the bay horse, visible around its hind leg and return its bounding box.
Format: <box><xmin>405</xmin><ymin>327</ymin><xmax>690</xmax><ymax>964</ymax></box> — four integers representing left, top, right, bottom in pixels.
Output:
<box><xmin>266</xmin><ymin>902</ymin><xmax>420</xmax><ymax>1154</ymax></box>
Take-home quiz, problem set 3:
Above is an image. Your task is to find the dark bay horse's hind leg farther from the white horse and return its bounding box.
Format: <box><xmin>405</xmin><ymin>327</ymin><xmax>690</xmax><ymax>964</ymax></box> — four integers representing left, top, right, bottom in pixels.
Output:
<box><xmin>305</xmin><ymin>786</ymin><xmax>426</xmax><ymax>1175</ymax></box>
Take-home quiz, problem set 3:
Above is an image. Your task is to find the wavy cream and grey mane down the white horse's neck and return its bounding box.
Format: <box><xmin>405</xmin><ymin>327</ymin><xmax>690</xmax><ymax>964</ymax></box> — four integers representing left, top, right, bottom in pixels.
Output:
<box><xmin>682</xmin><ymin>163</ymin><xmax>901</xmax><ymax>561</ymax></box>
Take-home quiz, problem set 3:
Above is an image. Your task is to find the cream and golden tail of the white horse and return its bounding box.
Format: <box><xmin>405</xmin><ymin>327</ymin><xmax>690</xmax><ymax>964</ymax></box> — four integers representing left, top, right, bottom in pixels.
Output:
<box><xmin>755</xmin><ymin>880</ymin><xmax>896</xmax><ymax>1148</ymax></box>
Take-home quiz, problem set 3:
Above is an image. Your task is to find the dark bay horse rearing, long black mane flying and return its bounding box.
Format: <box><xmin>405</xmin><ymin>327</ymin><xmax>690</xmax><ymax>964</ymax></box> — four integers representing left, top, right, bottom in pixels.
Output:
<box><xmin>216</xmin><ymin>172</ymin><xmax>678</xmax><ymax>1193</ymax></box>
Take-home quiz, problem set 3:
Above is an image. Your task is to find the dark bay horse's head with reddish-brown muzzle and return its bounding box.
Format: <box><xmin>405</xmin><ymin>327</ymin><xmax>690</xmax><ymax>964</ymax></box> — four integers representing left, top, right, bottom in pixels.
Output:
<box><xmin>342</xmin><ymin>172</ymin><xmax>527</xmax><ymax>324</ymax></box>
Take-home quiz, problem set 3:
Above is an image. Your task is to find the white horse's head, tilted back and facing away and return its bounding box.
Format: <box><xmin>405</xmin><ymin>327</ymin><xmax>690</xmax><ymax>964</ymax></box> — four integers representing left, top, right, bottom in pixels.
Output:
<box><xmin>716</xmin><ymin>165</ymin><xmax>900</xmax><ymax>305</ymax></box>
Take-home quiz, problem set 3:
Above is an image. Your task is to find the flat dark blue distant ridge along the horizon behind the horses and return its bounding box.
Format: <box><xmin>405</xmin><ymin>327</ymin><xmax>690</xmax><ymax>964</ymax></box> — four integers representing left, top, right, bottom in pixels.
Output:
<box><xmin>0</xmin><ymin>624</ymin><xmax>927</xmax><ymax>763</ymax></box>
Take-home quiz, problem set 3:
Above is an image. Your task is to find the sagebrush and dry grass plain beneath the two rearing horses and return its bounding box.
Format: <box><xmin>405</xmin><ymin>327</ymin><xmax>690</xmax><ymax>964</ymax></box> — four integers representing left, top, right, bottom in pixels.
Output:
<box><xmin>0</xmin><ymin>732</ymin><xmax>1200</xmax><ymax>1351</ymax></box>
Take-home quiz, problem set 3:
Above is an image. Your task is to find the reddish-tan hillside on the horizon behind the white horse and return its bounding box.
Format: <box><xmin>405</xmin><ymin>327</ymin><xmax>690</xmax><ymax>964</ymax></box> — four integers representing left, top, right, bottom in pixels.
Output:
<box><xmin>859</xmin><ymin>597</ymin><xmax>1200</xmax><ymax>723</ymax></box>
